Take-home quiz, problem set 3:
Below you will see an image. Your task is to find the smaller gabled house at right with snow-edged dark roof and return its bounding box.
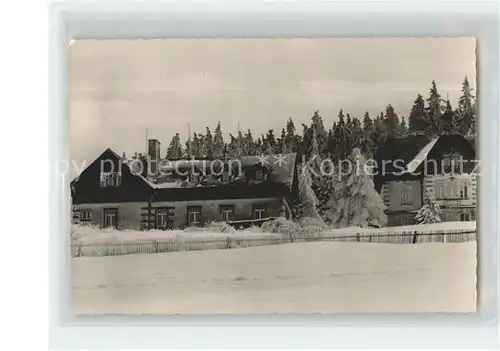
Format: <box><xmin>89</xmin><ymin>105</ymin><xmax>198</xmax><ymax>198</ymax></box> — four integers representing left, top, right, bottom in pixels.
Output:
<box><xmin>374</xmin><ymin>133</ymin><xmax>477</xmax><ymax>225</ymax></box>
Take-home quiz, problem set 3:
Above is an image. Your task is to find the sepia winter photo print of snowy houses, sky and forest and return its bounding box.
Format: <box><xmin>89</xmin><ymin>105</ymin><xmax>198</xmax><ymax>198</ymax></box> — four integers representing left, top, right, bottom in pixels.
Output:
<box><xmin>66</xmin><ymin>37</ymin><xmax>476</xmax><ymax>315</ymax></box>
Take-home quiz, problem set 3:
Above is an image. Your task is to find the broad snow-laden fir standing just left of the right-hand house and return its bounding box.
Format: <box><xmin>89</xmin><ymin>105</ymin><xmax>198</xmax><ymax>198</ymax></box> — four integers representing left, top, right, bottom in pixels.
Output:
<box><xmin>326</xmin><ymin>148</ymin><xmax>387</xmax><ymax>228</ymax></box>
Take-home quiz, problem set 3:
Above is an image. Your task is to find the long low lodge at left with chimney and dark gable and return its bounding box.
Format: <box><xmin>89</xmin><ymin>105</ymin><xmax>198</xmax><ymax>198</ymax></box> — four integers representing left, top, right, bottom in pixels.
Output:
<box><xmin>71</xmin><ymin>141</ymin><xmax>297</xmax><ymax>230</ymax></box>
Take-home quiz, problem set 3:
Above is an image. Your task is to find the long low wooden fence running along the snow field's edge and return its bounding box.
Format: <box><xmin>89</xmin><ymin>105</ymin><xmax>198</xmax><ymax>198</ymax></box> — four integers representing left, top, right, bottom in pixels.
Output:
<box><xmin>71</xmin><ymin>229</ymin><xmax>476</xmax><ymax>257</ymax></box>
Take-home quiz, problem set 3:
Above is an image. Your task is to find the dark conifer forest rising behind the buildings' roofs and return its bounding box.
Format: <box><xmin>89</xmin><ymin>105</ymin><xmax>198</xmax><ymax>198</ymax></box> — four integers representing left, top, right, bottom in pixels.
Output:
<box><xmin>134</xmin><ymin>77</ymin><xmax>476</xmax><ymax>160</ymax></box>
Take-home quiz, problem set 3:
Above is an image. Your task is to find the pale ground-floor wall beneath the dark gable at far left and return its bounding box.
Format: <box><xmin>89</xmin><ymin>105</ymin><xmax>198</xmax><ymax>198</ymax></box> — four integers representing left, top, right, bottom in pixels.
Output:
<box><xmin>73</xmin><ymin>202</ymin><xmax>148</xmax><ymax>230</ymax></box>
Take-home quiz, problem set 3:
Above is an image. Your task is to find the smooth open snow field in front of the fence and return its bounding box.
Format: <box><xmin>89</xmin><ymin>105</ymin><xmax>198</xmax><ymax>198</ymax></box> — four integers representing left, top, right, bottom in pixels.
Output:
<box><xmin>72</xmin><ymin>242</ymin><xmax>476</xmax><ymax>314</ymax></box>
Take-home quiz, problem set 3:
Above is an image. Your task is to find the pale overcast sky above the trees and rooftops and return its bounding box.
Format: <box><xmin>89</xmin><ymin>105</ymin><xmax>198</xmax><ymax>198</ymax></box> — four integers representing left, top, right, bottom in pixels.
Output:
<box><xmin>68</xmin><ymin>38</ymin><xmax>476</xmax><ymax>164</ymax></box>
